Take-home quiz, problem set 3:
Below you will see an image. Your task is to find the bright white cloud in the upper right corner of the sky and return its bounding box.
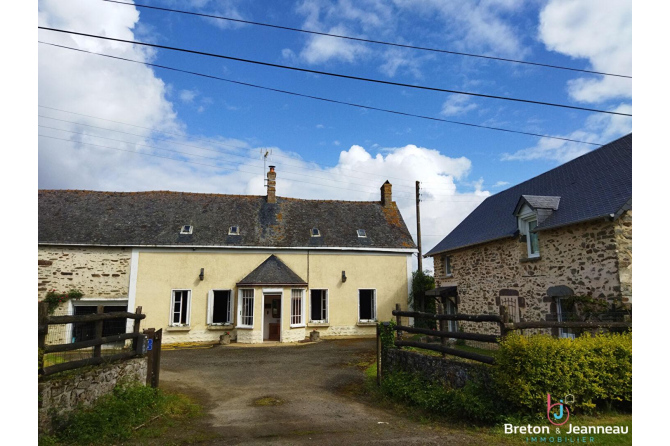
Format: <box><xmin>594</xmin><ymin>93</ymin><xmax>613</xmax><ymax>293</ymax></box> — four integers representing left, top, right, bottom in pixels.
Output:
<box><xmin>539</xmin><ymin>0</ymin><xmax>633</xmax><ymax>103</ymax></box>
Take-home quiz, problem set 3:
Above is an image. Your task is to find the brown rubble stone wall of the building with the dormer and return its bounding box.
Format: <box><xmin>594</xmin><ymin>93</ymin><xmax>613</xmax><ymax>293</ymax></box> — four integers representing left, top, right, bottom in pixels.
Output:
<box><xmin>434</xmin><ymin>219</ymin><xmax>632</xmax><ymax>334</ymax></box>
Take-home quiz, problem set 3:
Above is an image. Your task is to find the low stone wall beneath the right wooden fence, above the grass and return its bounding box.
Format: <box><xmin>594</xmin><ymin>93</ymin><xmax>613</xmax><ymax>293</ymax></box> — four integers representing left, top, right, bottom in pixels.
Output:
<box><xmin>383</xmin><ymin>348</ymin><xmax>489</xmax><ymax>389</ymax></box>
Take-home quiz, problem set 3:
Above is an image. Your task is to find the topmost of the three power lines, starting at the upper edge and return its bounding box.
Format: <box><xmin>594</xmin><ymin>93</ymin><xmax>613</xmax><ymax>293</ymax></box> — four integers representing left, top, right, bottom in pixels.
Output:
<box><xmin>103</xmin><ymin>0</ymin><xmax>633</xmax><ymax>79</ymax></box>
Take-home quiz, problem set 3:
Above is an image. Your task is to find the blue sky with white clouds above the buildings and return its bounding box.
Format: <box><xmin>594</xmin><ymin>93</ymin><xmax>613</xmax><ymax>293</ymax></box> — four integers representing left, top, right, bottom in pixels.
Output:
<box><xmin>38</xmin><ymin>0</ymin><xmax>632</xmax><ymax>270</ymax></box>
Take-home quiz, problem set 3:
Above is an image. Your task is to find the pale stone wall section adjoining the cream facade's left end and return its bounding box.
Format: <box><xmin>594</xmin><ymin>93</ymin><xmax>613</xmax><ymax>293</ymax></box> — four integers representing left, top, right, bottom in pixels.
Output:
<box><xmin>37</xmin><ymin>246</ymin><xmax>131</xmax><ymax>299</ymax></box>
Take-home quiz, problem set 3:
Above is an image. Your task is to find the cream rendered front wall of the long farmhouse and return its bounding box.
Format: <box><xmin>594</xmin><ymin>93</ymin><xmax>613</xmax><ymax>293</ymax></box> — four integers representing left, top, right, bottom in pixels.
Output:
<box><xmin>133</xmin><ymin>248</ymin><xmax>411</xmax><ymax>343</ymax></box>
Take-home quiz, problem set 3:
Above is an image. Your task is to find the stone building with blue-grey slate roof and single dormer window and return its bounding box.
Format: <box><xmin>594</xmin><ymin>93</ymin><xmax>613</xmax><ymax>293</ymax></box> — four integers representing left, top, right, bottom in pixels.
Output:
<box><xmin>426</xmin><ymin>134</ymin><xmax>633</xmax><ymax>337</ymax></box>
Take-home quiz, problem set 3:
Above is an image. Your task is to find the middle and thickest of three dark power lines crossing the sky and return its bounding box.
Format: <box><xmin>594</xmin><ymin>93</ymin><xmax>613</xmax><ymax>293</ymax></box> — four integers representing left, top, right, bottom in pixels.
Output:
<box><xmin>37</xmin><ymin>26</ymin><xmax>633</xmax><ymax>116</ymax></box>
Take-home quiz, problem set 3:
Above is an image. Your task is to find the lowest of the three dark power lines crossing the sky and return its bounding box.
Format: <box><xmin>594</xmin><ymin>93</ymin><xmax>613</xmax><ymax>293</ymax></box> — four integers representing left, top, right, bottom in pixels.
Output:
<box><xmin>38</xmin><ymin>41</ymin><xmax>602</xmax><ymax>146</ymax></box>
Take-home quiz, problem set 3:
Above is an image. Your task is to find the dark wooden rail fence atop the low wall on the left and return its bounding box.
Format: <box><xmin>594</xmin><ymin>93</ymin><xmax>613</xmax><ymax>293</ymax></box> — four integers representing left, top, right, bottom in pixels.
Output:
<box><xmin>38</xmin><ymin>302</ymin><xmax>146</xmax><ymax>375</ymax></box>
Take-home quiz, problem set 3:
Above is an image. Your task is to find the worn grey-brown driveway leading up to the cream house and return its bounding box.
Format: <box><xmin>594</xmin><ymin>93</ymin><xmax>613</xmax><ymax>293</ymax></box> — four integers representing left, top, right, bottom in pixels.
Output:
<box><xmin>160</xmin><ymin>339</ymin><xmax>490</xmax><ymax>446</ymax></box>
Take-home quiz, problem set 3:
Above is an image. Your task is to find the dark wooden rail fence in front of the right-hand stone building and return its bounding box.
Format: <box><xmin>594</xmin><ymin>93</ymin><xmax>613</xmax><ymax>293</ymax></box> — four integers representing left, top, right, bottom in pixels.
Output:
<box><xmin>392</xmin><ymin>304</ymin><xmax>632</xmax><ymax>364</ymax></box>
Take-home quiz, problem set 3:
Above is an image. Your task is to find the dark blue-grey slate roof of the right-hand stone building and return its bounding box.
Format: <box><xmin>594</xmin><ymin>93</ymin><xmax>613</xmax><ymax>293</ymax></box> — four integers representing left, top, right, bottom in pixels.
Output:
<box><xmin>426</xmin><ymin>133</ymin><xmax>633</xmax><ymax>256</ymax></box>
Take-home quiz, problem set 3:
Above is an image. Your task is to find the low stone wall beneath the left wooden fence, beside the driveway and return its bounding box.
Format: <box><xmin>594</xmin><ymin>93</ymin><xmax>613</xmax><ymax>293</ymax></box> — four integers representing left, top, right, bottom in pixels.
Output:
<box><xmin>38</xmin><ymin>358</ymin><xmax>147</xmax><ymax>432</ymax></box>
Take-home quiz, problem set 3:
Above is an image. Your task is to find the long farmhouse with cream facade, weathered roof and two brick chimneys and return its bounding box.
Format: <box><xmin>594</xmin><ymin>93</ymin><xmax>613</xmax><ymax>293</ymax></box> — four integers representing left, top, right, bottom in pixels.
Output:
<box><xmin>38</xmin><ymin>166</ymin><xmax>416</xmax><ymax>343</ymax></box>
